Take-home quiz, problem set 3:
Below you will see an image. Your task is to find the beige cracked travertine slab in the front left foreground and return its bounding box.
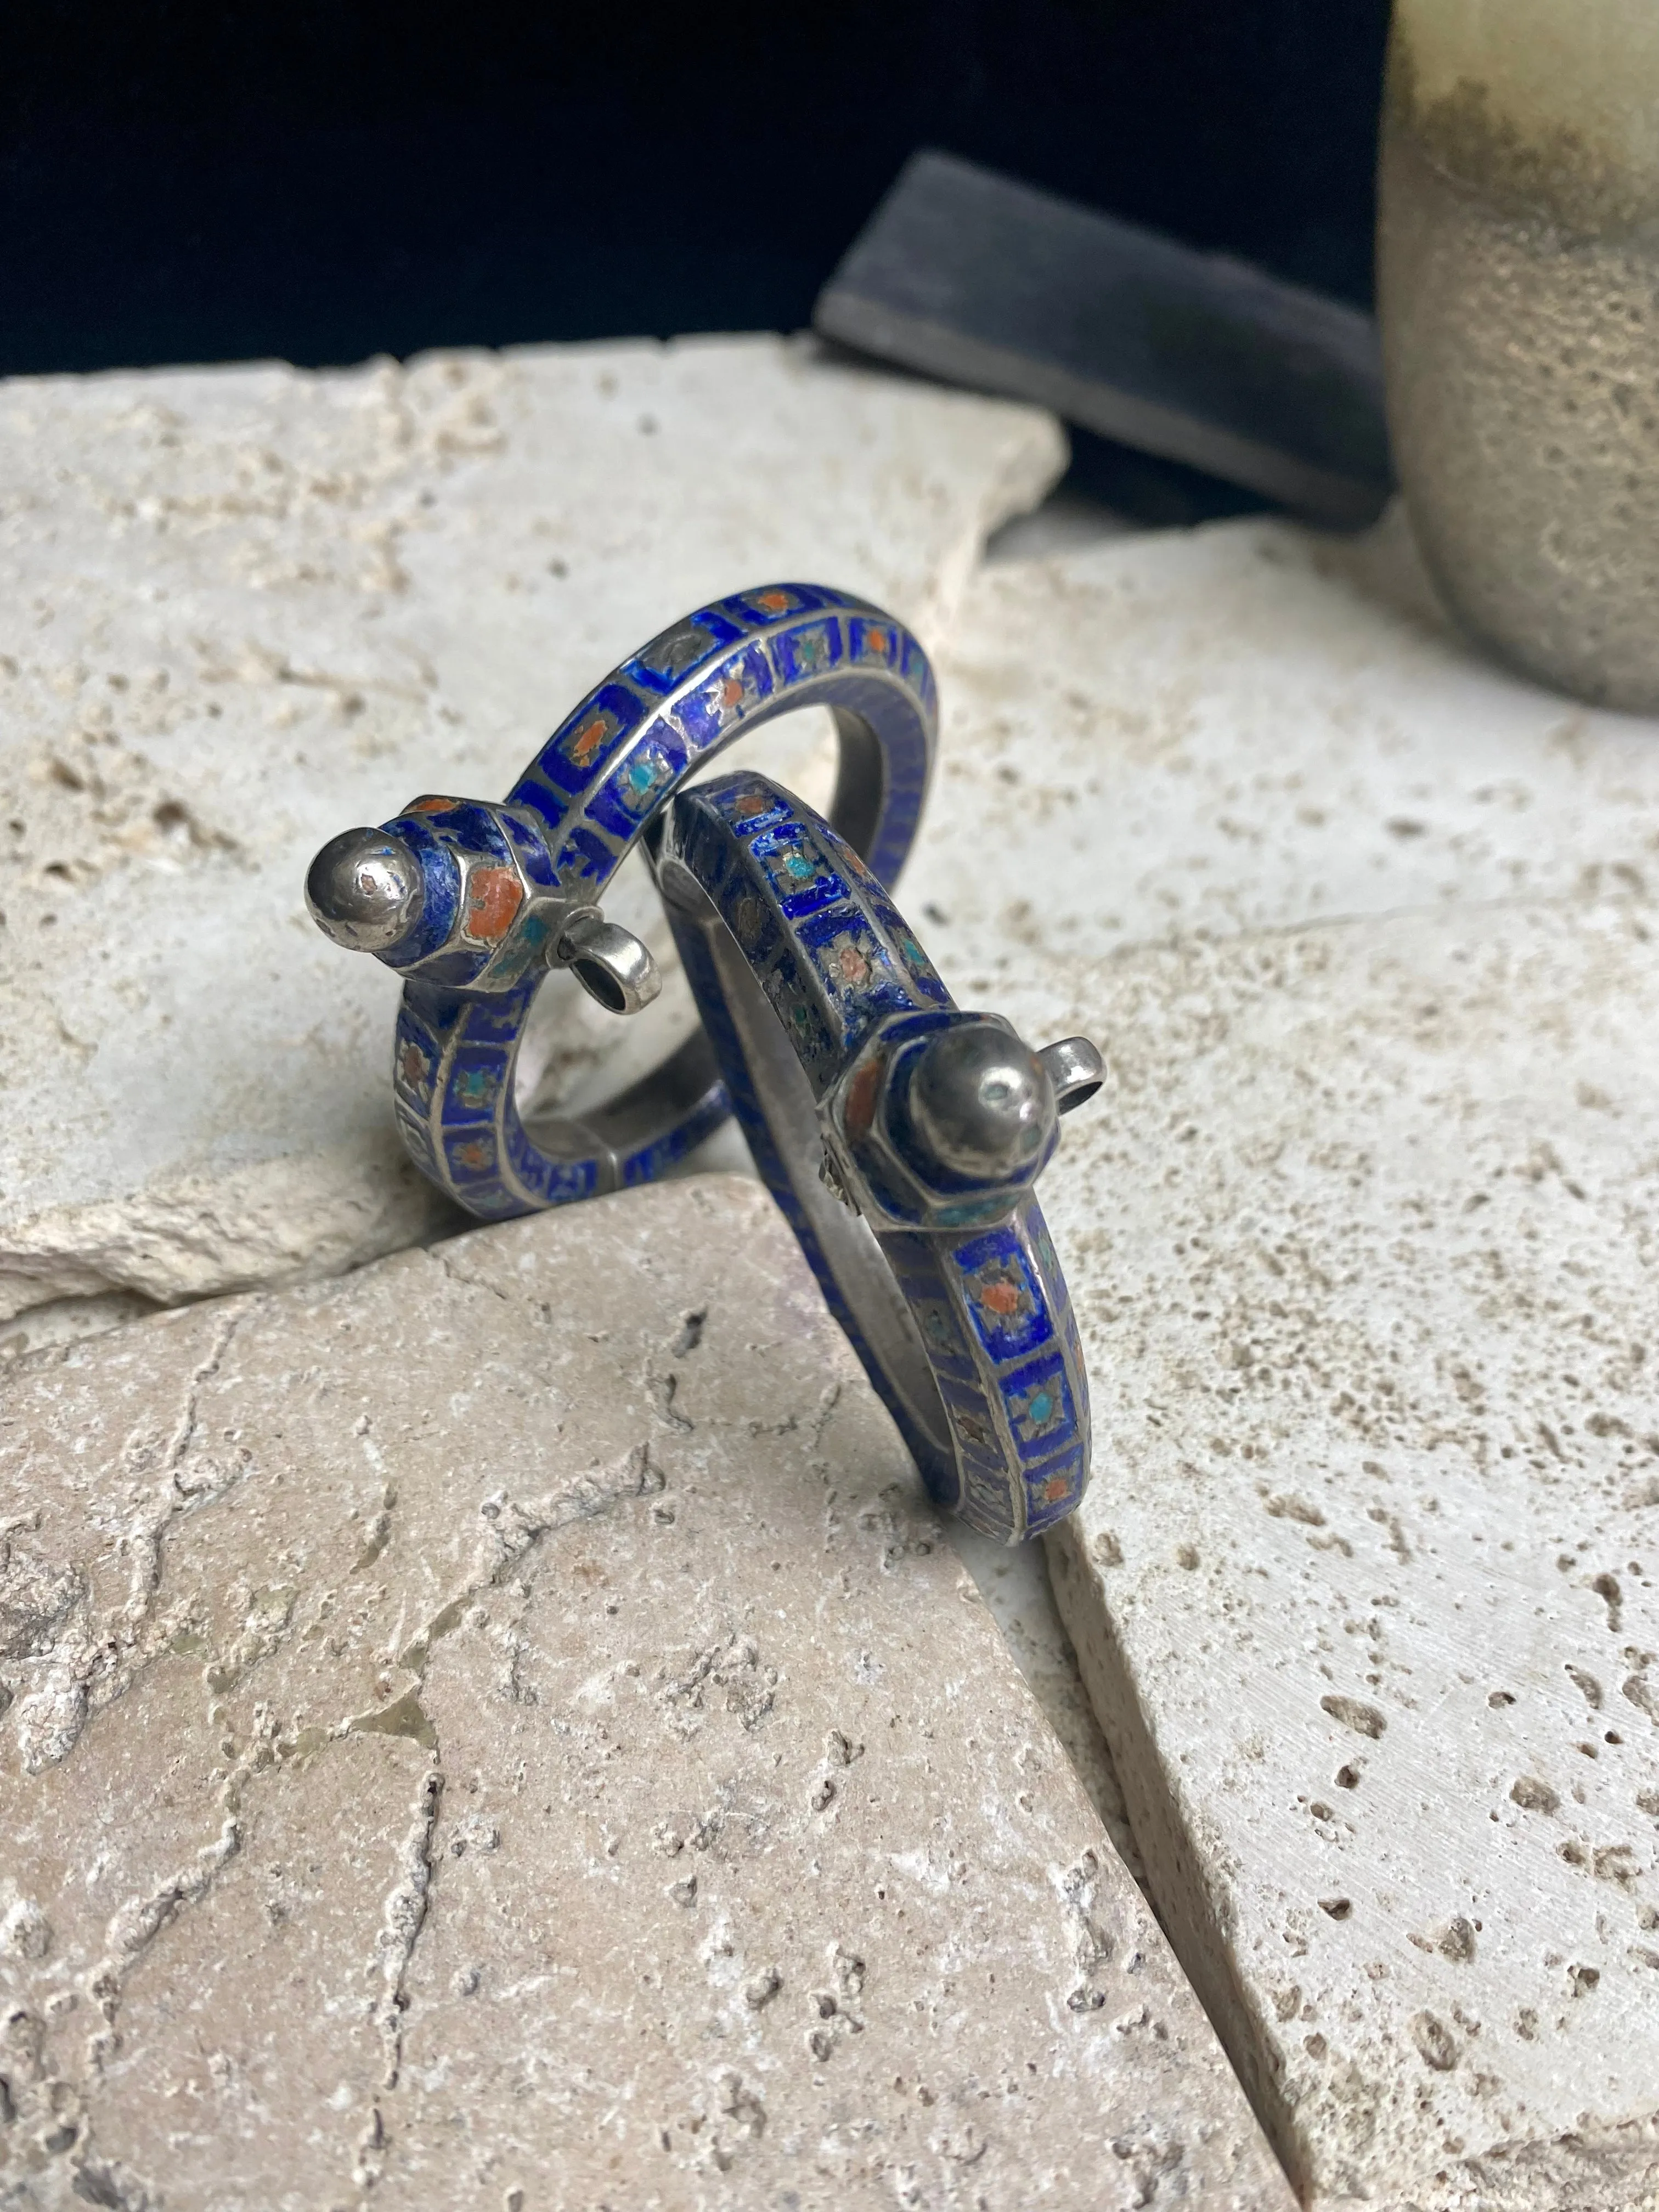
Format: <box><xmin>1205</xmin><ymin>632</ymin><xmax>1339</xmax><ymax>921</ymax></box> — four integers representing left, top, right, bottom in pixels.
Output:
<box><xmin>0</xmin><ymin>1179</ymin><xmax>1290</xmax><ymax>2212</ymax></box>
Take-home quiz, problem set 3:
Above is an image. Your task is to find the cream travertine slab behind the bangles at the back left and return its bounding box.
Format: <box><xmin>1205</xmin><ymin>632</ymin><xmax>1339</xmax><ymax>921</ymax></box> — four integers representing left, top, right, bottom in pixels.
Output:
<box><xmin>0</xmin><ymin>338</ymin><xmax>1064</xmax><ymax>1318</ymax></box>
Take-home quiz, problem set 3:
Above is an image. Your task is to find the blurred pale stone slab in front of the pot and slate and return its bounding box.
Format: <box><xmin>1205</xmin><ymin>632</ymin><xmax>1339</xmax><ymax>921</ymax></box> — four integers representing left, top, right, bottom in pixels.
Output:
<box><xmin>905</xmin><ymin>513</ymin><xmax>1659</xmax><ymax>986</ymax></box>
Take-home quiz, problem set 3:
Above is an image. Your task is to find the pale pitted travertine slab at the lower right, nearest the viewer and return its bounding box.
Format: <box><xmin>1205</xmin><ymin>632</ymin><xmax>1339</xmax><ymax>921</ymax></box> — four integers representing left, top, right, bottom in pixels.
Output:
<box><xmin>1009</xmin><ymin>902</ymin><xmax>1659</xmax><ymax>2212</ymax></box>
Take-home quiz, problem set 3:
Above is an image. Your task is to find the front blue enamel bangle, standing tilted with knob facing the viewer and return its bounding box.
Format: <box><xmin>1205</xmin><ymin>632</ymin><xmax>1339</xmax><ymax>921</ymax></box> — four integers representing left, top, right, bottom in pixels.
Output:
<box><xmin>650</xmin><ymin>774</ymin><xmax>1102</xmax><ymax>1544</ymax></box>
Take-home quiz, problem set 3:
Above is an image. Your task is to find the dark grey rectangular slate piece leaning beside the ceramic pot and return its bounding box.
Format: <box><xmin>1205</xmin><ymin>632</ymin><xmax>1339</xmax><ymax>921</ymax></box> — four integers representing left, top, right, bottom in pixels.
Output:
<box><xmin>814</xmin><ymin>153</ymin><xmax>1391</xmax><ymax>527</ymax></box>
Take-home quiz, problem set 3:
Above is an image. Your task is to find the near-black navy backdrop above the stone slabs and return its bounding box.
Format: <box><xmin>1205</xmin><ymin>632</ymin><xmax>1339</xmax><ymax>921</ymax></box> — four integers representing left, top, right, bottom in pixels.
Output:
<box><xmin>0</xmin><ymin>0</ymin><xmax>1387</xmax><ymax>374</ymax></box>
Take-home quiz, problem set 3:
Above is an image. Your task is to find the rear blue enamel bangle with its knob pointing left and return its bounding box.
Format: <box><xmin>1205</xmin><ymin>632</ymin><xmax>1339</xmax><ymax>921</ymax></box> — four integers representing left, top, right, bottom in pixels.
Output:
<box><xmin>305</xmin><ymin>584</ymin><xmax>938</xmax><ymax>1219</ymax></box>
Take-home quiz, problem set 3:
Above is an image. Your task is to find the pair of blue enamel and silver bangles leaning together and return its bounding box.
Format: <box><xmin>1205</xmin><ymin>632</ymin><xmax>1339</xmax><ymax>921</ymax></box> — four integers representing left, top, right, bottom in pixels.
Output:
<box><xmin>305</xmin><ymin>584</ymin><xmax>1099</xmax><ymax>1542</ymax></box>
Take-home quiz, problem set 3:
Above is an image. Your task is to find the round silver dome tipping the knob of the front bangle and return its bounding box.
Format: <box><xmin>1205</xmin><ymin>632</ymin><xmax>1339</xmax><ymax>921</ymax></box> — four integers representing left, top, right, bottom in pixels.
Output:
<box><xmin>909</xmin><ymin>1022</ymin><xmax>1059</xmax><ymax>1183</ymax></box>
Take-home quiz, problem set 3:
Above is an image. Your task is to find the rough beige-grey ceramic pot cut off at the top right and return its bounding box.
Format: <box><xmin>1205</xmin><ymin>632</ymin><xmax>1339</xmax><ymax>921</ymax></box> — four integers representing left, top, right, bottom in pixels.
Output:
<box><xmin>1378</xmin><ymin>0</ymin><xmax>1659</xmax><ymax>712</ymax></box>
